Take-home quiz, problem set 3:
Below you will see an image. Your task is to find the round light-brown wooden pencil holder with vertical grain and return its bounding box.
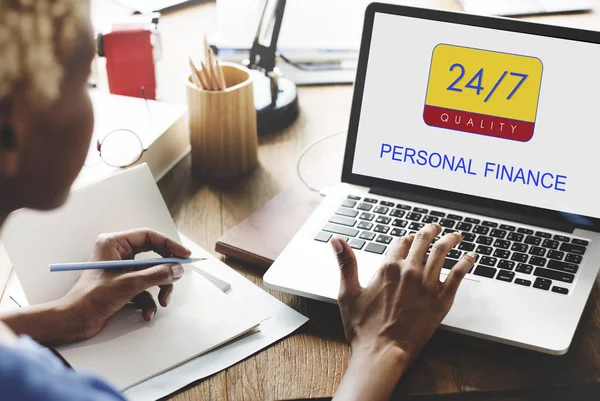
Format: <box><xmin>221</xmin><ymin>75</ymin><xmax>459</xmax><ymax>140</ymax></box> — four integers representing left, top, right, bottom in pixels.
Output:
<box><xmin>186</xmin><ymin>63</ymin><xmax>258</xmax><ymax>178</ymax></box>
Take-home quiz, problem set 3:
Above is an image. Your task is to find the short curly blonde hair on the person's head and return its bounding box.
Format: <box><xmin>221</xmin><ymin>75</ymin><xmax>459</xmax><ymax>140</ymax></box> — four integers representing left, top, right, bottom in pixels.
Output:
<box><xmin>0</xmin><ymin>0</ymin><xmax>89</xmax><ymax>106</ymax></box>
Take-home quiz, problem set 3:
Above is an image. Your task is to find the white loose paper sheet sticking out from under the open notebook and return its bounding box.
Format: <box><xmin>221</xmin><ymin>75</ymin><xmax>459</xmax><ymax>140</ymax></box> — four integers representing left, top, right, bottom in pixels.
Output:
<box><xmin>125</xmin><ymin>234</ymin><xmax>308</xmax><ymax>401</ymax></box>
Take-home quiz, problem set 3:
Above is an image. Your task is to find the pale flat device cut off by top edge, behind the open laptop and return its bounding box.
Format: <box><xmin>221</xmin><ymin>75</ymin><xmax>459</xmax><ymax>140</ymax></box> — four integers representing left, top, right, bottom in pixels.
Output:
<box><xmin>460</xmin><ymin>0</ymin><xmax>596</xmax><ymax>16</ymax></box>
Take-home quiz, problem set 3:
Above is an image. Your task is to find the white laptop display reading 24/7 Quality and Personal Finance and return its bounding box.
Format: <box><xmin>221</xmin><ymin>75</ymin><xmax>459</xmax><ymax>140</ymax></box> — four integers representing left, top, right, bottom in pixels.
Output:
<box><xmin>351</xmin><ymin>13</ymin><xmax>600</xmax><ymax>218</ymax></box>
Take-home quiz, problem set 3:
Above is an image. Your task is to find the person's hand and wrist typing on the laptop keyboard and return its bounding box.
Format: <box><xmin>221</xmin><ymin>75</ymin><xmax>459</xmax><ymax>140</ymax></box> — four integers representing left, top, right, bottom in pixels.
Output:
<box><xmin>331</xmin><ymin>224</ymin><xmax>475</xmax><ymax>400</ymax></box>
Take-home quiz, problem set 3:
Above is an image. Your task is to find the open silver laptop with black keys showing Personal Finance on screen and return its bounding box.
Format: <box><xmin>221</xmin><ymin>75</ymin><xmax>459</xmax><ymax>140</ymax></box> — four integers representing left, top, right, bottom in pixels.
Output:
<box><xmin>264</xmin><ymin>3</ymin><xmax>600</xmax><ymax>355</ymax></box>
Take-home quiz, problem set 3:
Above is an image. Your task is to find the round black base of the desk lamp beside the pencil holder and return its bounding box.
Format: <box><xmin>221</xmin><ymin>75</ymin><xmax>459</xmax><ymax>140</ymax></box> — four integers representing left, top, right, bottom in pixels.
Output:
<box><xmin>250</xmin><ymin>70</ymin><xmax>298</xmax><ymax>135</ymax></box>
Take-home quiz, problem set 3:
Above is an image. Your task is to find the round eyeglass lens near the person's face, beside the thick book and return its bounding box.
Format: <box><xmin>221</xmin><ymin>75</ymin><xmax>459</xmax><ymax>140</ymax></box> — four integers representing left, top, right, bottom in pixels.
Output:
<box><xmin>100</xmin><ymin>130</ymin><xmax>144</xmax><ymax>167</ymax></box>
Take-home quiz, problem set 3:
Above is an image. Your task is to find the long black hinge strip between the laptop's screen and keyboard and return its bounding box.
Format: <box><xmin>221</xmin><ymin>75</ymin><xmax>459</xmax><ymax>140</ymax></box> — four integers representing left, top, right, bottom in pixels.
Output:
<box><xmin>369</xmin><ymin>188</ymin><xmax>576</xmax><ymax>233</ymax></box>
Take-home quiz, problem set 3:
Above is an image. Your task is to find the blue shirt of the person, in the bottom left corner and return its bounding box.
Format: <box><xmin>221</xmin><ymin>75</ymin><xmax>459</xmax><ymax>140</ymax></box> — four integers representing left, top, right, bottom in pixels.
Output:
<box><xmin>0</xmin><ymin>336</ymin><xmax>125</xmax><ymax>401</ymax></box>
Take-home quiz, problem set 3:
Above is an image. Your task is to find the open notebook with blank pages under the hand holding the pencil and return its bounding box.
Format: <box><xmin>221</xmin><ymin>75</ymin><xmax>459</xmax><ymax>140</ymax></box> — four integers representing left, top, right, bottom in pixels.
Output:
<box><xmin>2</xmin><ymin>165</ymin><xmax>269</xmax><ymax>390</ymax></box>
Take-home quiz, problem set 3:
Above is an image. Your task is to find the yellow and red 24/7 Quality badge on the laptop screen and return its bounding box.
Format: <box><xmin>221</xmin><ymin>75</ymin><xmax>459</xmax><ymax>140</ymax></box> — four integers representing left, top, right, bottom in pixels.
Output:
<box><xmin>423</xmin><ymin>44</ymin><xmax>543</xmax><ymax>142</ymax></box>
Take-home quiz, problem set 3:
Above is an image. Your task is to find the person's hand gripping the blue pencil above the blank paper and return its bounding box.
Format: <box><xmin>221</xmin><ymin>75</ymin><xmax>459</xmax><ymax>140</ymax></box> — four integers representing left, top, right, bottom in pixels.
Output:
<box><xmin>61</xmin><ymin>229</ymin><xmax>191</xmax><ymax>340</ymax></box>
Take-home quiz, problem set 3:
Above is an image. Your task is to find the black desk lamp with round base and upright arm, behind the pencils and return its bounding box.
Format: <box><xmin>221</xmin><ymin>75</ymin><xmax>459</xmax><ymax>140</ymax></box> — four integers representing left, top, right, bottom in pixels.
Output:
<box><xmin>246</xmin><ymin>0</ymin><xmax>298</xmax><ymax>135</ymax></box>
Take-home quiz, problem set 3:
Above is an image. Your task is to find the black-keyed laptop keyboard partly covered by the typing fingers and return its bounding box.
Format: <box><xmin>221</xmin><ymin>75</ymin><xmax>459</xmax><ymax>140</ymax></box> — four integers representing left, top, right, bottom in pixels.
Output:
<box><xmin>314</xmin><ymin>195</ymin><xmax>589</xmax><ymax>295</ymax></box>
